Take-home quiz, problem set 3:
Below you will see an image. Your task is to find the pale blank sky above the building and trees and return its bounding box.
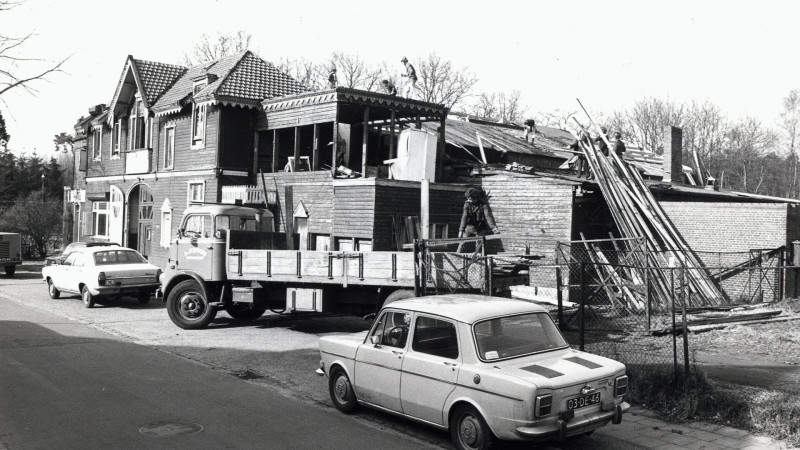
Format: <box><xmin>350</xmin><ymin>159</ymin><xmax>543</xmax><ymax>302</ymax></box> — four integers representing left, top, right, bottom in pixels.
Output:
<box><xmin>0</xmin><ymin>0</ymin><xmax>800</xmax><ymax>156</ymax></box>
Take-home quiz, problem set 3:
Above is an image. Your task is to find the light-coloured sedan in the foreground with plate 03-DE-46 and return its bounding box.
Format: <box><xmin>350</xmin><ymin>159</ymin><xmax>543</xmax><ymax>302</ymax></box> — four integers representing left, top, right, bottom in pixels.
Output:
<box><xmin>317</xmin><ymin>295</ymin><xmax>630</xmax><ymax>449</ymax></box>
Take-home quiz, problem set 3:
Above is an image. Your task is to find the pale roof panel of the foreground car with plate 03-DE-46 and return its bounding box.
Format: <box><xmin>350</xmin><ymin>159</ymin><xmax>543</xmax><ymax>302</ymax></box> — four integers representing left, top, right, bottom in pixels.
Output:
<box><xmin>387</xmin><ymin>294</ymin><xmax>547</xmax><ymax>324</ymax></box>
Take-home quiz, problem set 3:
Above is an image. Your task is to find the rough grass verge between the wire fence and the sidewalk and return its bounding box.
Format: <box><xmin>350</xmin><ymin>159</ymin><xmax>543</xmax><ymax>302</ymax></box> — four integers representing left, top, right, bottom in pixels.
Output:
<box><xmin>628</xmin><ymin>366</ymin><xmax>800</xmax><ymax>446</ymax></box>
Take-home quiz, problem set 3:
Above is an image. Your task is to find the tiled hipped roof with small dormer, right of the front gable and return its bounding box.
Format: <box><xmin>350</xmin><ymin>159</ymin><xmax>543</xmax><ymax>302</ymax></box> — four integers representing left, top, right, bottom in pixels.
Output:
<box><xmin>153</xmin><ymin>50</ymin><xmax>305</xmax><ymax>115</ymax></box>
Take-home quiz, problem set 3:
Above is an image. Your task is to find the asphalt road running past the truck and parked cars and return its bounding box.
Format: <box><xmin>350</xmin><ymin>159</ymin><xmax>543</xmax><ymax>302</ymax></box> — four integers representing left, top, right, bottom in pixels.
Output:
<box><xmin>0</xmin><ymin>272</ymin><xmax>643</xmax><ymax>450</ymax></box>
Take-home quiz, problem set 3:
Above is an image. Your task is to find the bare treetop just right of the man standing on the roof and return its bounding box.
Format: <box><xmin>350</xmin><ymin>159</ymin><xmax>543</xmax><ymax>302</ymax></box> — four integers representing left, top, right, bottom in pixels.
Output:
<box><xmin>416</xmin><ymin>53</ymin><xmax>478</xmax><ymax>109</ymax></box>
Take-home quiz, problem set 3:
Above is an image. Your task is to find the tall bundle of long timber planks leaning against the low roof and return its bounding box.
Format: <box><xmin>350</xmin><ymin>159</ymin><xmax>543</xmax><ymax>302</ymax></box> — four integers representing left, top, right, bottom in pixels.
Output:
<box><xmin>575</xmin><ymin>112</ymin><xmax>725</xmax><ymax>310</ymax></box>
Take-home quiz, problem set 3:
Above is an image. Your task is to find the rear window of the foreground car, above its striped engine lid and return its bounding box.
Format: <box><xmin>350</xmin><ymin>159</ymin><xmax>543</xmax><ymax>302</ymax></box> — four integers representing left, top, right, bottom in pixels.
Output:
<box><xmin>472</xmin><ymin>313</ymin><xmax>567</xmax><ymax>361</ymax></box>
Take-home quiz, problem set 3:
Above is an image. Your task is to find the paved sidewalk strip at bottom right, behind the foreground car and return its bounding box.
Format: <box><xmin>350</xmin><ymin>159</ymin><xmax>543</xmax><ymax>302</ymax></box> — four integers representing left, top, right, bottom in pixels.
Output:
<box><xmin>595</xmin><ymin>407</ymin><xmax>792</xmax><ymax>450</ymax></box>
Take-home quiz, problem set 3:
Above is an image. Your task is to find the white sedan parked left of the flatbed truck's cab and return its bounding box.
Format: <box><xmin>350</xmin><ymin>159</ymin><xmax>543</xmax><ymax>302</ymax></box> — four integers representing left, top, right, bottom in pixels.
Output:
<box><xmin>42</xmin><ymin>244</ymin><xmax>161</xmax><ymax>308</ymax></box>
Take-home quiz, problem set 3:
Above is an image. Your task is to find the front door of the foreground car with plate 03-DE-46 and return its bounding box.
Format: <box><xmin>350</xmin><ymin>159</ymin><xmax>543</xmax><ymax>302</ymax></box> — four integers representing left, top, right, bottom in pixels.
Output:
<box><xmin>354</xmin><ymin>310</ymin><xmax>411</xmax><ymax>412</ymax></box>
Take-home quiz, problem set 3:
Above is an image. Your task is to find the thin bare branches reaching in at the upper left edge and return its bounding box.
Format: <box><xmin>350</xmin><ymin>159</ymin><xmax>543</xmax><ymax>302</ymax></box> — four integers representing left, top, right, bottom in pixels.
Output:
<box><xmin>0</xmin><ymin>0</ymin><xmax>69</xmax><ymax>99</ymax></box>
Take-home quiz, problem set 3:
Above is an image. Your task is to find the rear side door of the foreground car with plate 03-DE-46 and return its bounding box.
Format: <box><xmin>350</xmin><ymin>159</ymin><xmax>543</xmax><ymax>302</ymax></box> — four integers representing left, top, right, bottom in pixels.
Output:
<box><xmin>400</xmin><ymin>315</ymin><xmax>461</xmax><ymax>425</ymax></box>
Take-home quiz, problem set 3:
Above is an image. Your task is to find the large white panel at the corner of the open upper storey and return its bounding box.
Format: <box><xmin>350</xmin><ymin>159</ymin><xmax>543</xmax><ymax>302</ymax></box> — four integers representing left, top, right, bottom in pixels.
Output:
<box><xmin>384</xmin><ymin>128</ymin><xmax>437</xmax><ymax>181</ymax></box>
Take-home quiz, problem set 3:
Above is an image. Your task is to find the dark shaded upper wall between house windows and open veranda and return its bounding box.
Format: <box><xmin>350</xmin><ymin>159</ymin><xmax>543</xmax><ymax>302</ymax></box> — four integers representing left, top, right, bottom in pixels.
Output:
<box><xmin>219</xmin><ymin>107</ymin><xmax>253</xmax><ymax>171</ymax></box>
